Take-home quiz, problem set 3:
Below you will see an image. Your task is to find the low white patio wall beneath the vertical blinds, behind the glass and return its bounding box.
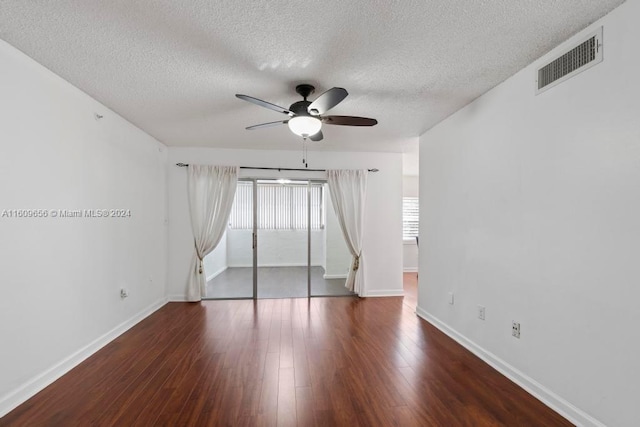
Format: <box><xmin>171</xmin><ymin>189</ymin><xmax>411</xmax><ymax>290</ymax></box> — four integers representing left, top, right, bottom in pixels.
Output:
<box><xmin>227</xmin><ymin>230</ymin><xmax>324</xmax><ymax>267</ymax></box>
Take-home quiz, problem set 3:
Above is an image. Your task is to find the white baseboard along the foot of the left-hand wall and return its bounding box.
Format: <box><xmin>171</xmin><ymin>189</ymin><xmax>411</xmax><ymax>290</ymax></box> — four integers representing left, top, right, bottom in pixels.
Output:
<box><xmin>0</xmin><ymin>298</ymin><xmax>167</xmax><ymax>417</ymax></box>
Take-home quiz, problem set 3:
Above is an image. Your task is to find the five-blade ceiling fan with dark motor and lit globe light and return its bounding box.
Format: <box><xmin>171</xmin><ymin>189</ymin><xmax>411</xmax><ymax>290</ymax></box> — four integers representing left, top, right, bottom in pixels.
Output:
<box><xmin>236</xmin><ymin>84</ymin><xmax>378</xmax><ymax>141</ymax></box>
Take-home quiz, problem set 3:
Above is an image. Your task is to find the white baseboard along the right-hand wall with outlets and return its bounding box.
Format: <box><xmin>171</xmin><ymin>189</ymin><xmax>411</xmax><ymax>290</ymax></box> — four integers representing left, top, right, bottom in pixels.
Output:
<box><xmin>416</xmin><ymin>307</ymin><xmax>605</xmax><ymax>427</ymax></box>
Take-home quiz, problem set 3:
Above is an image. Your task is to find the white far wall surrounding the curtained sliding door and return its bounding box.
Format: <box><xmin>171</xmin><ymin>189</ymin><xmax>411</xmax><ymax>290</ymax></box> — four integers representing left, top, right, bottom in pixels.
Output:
<box><xmin>168</xmin><ymin>148</ymin><xmax>402</xmax><ymax>299</ymax></box>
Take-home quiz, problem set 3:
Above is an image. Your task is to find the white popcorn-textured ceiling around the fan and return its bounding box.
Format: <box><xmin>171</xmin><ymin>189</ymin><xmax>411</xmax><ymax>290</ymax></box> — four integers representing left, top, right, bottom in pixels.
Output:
<box><xmin>0</xmin><ymin>0</ymin><xmax>623</xmax><ymax>152</ymax></box>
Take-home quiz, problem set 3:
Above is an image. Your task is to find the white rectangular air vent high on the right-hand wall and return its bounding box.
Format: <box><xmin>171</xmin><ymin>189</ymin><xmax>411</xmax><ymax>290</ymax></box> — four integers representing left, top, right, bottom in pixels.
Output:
<box><xmin>536</xmin><ymin>27</ymin><xmax>602</xmax><ymax>95</ymax></box>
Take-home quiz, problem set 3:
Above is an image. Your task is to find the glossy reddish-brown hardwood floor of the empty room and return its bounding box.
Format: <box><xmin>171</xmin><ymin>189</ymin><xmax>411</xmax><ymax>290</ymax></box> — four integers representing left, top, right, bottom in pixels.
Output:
<box><xmin>0</xmin><ymin>297</ymin><xmax>571</xmax><ymax>426</ymax></box>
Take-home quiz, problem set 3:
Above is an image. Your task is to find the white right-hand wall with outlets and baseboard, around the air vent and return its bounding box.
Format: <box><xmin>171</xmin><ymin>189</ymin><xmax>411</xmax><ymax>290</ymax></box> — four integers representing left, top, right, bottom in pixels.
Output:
<box><xmin>418</xmin><ymin>0</ymin><xmax>640</xmax><ymax>426</ymax></box>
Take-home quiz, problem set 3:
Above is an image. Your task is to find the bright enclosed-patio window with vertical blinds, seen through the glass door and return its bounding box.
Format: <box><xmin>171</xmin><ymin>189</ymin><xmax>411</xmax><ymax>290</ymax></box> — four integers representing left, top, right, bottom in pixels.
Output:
<box><xmin>229</xmin><ymin>181</ymin><xmax>324</xmax><ymax>230</ymax></box>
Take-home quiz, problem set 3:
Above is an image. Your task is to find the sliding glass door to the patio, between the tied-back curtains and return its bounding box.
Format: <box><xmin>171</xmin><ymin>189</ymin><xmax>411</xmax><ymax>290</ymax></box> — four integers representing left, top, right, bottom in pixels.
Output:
<box><xmin>205</xmin><ymin>179</ymin><xmax>353</xmax><ymax>299</ymax></box>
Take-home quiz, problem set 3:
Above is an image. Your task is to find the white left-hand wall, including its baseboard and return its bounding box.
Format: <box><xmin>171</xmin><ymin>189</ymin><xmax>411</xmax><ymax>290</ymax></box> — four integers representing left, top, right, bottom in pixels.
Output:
<box><xmin>0</xmin><ymin>41</ymin><xmax>167</xmax><ymax>416</ymax></box>
